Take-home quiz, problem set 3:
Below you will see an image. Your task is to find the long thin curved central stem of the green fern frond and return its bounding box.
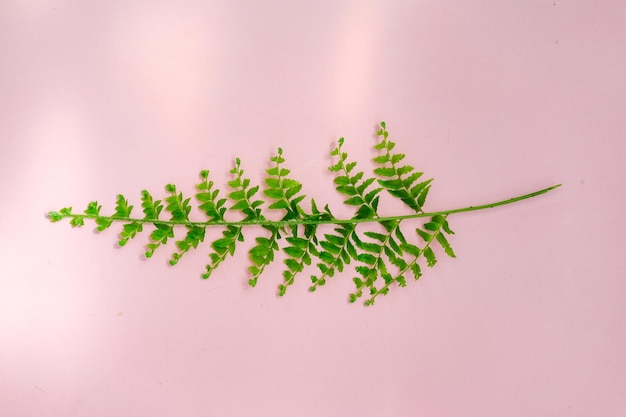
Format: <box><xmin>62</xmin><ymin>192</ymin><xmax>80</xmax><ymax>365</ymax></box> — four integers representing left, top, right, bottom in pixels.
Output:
<box><xmin>48</xmin><ymin>184</ymin><xmax>562</xmax><ymax>227</ymax></box>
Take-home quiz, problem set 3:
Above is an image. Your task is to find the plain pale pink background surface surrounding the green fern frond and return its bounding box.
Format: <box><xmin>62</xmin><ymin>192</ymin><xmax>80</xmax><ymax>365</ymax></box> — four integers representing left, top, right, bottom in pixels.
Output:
<box><xmin>0</xmin><ymin>0</ymin><xmax>626</xmax><ymax>417</ymax></box>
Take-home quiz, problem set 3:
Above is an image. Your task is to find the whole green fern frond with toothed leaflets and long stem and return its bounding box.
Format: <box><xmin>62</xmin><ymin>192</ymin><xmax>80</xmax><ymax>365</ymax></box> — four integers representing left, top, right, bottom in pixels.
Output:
<box><xmin>47</xmin><ymin>122</ymin><xmax>560</xmax><ymax>305</ymax></box>
